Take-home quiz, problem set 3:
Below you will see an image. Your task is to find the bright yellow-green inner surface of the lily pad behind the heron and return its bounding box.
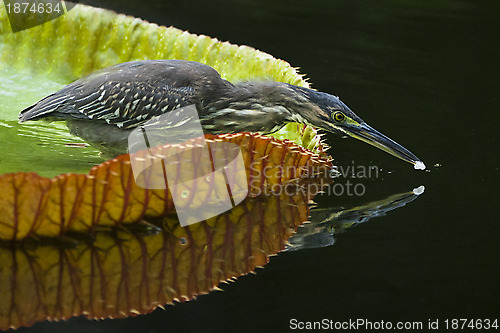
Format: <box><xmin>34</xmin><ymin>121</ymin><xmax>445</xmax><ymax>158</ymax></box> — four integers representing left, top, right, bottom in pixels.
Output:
<box><xmin>0</xmin><ymin>5</ymin><xmax>322</xmax><ymax>177</ymax></box>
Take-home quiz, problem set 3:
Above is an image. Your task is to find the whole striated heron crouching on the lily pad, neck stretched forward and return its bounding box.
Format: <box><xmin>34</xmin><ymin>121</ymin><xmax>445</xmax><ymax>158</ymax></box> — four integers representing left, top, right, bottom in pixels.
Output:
<box><xmin>19</xmin><ymin>60</ymin><xmax>425</xmax><ymax>169</ymax></box>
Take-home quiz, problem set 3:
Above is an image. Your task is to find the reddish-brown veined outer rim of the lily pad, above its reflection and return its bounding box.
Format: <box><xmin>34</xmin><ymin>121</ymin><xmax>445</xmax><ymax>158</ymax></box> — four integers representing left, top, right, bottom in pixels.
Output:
<box><xmin>0</xmin><ymin>133</ymin><xmax>331</xmax><ymax>240</ymax></box>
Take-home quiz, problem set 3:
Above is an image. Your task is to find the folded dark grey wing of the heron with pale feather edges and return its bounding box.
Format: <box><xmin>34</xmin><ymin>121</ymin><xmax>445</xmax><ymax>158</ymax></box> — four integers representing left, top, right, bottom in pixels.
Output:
<box><xmin>19</xmin><ymin>62</ymin><xmax>205</xmax><ymax>129</ymax></box>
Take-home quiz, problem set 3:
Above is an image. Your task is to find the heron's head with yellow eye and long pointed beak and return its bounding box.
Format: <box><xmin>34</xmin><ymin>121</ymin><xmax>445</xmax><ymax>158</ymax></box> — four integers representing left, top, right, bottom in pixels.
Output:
<box><xmin>292</xmin><ymin>88</ymin><xmax>425</xmax><ymax>169</ymax></box>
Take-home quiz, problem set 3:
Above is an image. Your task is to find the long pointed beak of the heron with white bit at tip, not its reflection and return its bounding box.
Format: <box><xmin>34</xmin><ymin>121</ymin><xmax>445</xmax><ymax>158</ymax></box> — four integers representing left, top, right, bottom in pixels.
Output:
<box><xmin>343</xmin><ymin>122</ymin><xmax>425</xmax><ymax>170</ymax></box>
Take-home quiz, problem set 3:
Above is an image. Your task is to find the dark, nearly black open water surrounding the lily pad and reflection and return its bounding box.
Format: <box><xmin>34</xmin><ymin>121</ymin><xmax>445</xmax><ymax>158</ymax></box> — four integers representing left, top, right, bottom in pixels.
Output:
<box><xmin>19</xmin><ymin>0</ymin><xmax>500</xmax><ymax>332</ymax></box>
